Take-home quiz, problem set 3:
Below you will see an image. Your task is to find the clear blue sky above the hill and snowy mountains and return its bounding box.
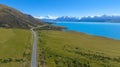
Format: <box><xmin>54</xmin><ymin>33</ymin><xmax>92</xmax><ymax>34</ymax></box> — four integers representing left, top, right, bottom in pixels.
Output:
<box><xmin>0</xmin><ymin>0</ymin><xmax>120</xmax><ymax>17</ymax></box>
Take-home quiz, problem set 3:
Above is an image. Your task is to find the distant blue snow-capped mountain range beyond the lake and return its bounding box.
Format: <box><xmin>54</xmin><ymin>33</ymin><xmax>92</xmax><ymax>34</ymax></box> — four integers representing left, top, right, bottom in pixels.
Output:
<box><xmin>39</xmin><ymin>15</ymin><xmax>120</xmax><ymax>22</ymax></box>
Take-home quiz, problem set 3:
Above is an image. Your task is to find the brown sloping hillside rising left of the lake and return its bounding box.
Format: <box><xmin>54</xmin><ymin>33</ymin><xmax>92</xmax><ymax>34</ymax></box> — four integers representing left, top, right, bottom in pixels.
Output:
<box><xmin>0</xmin><ymin>4</ymin><xmax>44</xmax><ymax>29</ymax></box>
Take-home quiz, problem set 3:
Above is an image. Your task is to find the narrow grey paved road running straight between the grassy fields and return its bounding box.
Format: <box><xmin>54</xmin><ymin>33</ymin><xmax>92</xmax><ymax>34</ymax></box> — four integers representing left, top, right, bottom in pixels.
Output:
<box><xmin>31</xmin><ymin>29</ymin><xmax>37</xmax><ymax>67</ymax></box>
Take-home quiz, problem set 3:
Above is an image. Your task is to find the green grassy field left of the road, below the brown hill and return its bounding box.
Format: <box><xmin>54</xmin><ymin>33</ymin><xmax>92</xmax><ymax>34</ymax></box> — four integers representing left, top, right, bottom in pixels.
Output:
<box><xmin>0</xmin><ymin>28</ymin><xmax>32</xmax><ymax>67</ymax></box>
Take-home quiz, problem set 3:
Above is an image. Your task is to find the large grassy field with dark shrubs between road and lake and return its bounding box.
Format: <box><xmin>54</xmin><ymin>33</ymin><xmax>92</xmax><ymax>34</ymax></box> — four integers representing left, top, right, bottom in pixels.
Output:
<box><xmin>37</xmin><ymin>30</ymin><xmax>120</xmax><ymax>67</ymax></box>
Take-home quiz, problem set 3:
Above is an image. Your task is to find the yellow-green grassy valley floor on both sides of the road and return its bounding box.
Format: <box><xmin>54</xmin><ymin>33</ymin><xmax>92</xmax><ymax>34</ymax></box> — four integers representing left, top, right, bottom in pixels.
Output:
<box><xmin>0</xmin><ymin>25</ymin><xmax>120</xmax><ymax>67</ymax></box>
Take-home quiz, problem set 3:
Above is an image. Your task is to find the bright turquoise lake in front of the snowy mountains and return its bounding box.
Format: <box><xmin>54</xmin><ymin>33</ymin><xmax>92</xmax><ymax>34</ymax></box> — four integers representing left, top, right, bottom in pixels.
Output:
<box><xmin>56</xmin><ymin>22</ymin><xmax>120</xmax><ymax>40</ymax></box>
